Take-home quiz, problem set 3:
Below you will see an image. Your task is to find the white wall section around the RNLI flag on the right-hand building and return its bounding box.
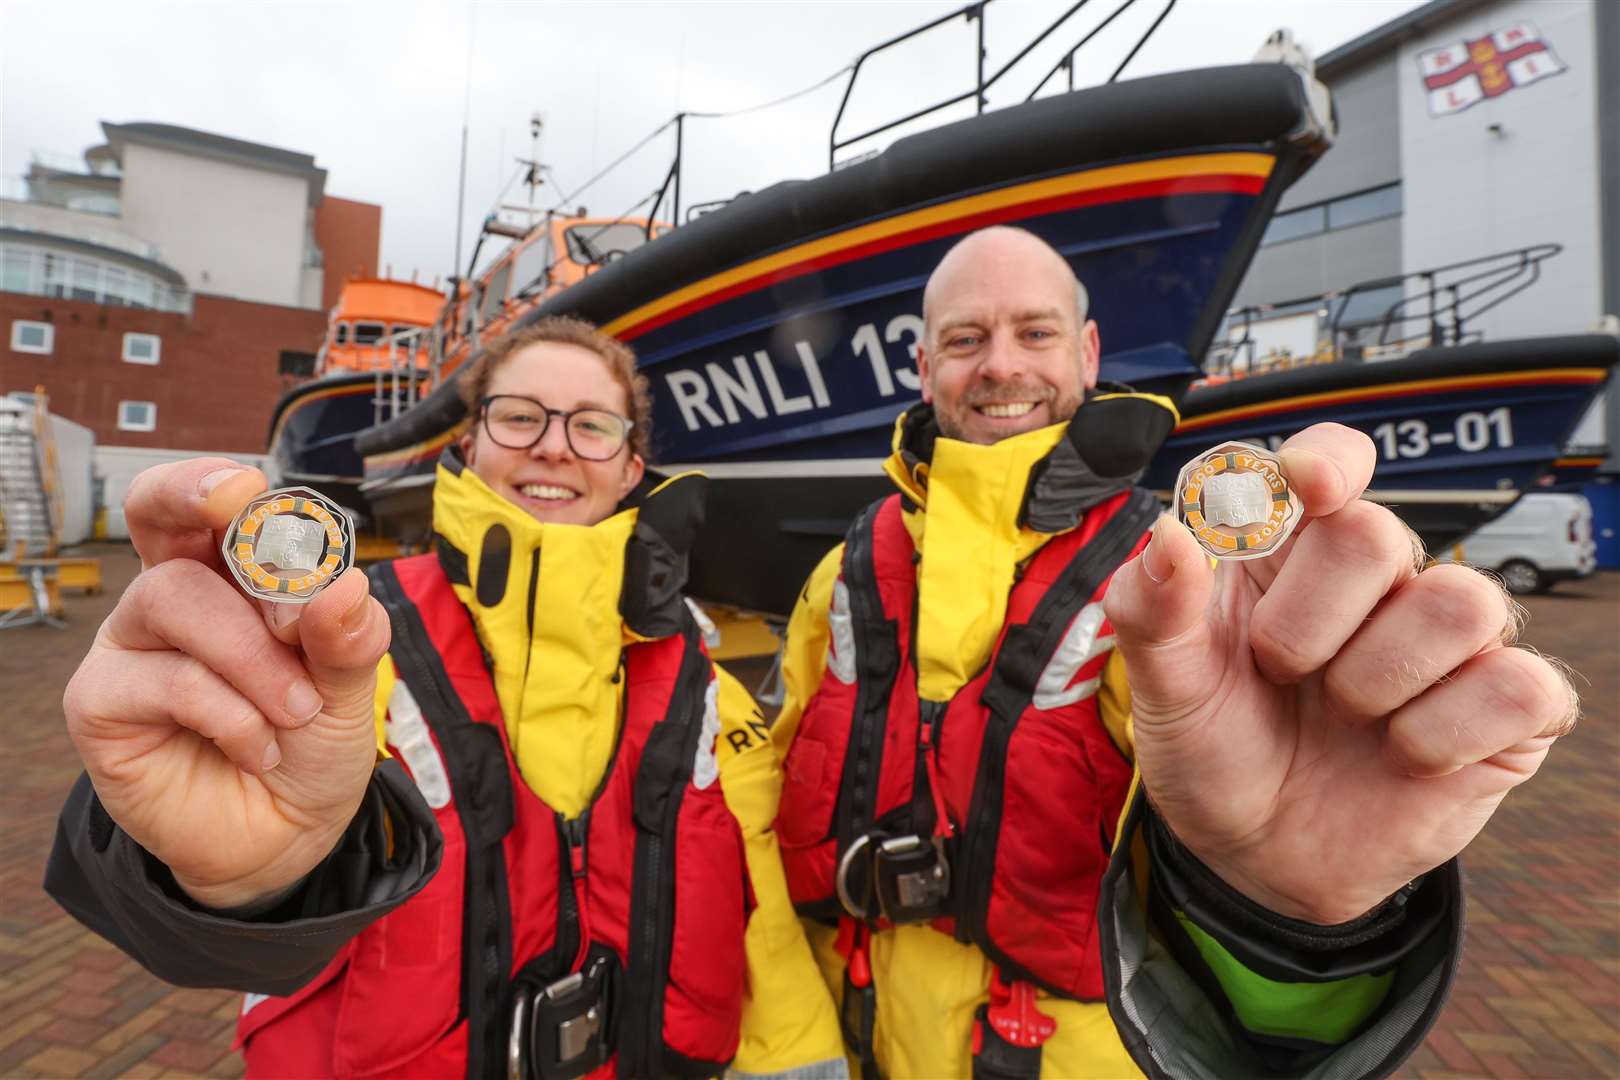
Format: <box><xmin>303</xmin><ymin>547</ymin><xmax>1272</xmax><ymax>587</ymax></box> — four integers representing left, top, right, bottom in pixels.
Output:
<box><xmin>1398</xmin><ymin>0</ymin><xmax>1607</xmax><ymax>340</ymax></box>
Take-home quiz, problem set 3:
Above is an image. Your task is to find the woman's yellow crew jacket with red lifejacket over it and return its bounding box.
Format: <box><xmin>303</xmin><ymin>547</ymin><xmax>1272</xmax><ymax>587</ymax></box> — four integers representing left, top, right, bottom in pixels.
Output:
<box><xmin>238</xmin><ymin>452</ymin><xmax>841</xmax><ymax>1078</ymax></box>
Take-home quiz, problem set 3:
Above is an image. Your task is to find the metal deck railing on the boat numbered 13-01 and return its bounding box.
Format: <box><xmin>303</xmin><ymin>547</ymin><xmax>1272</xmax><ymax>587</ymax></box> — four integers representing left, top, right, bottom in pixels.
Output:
<box><xmin>1204</xmin><ymin>243</ymin><xmax>1563</xmax><ymax>379</ymax></box>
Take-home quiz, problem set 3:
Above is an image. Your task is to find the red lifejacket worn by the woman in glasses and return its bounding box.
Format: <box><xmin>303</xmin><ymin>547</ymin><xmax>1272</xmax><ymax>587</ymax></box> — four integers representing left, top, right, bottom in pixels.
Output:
<box><xmin>238</xmin><ymin>555</ymin><xmax>752</xmax><ymax>1078</ymax></box>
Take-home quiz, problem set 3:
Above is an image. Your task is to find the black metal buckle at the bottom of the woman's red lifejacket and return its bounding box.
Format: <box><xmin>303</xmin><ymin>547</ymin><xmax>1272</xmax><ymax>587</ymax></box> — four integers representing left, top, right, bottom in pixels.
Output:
<box><xmin>507</xmin><ymin>957</ymin><xmax>611</xmax><ymax>1080</ymax></box>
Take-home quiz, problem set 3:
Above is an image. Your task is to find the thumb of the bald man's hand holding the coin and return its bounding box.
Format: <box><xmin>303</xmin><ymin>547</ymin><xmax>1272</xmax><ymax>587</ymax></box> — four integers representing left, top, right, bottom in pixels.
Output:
<box><xmin>1103</xmin><ymin>513</ymin><xmax>1217</xmax><ymax>722</ymax></box>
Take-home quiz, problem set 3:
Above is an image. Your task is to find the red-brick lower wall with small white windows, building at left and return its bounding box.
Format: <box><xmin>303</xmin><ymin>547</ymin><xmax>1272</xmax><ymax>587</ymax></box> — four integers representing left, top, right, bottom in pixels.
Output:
<box><xmin>0</xmin><ymin>293</ymin><xmax>326</xmax><ymax>453</ymax></box>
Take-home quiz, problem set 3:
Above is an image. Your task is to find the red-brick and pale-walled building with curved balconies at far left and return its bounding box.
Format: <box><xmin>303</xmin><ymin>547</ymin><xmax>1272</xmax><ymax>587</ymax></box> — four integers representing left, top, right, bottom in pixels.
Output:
<box><xmin>0</xmin><ymin>123</ymin><xmax>382</xmax><ymax>536</ymax></box>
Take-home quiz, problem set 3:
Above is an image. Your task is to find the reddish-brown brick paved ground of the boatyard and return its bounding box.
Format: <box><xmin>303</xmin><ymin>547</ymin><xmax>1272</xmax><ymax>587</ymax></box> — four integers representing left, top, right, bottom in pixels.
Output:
<box><xmin>0</xmin><ymin>546</ymin><xmax>1620</xmax><ymax>1080</ymax></box>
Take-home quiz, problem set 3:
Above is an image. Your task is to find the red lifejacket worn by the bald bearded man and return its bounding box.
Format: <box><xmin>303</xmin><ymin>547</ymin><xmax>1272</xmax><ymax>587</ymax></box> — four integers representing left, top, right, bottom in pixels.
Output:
<box><xmin>776</xmin><ymin>489</ymin><xmax>1158</xmax><ymax>1001</ymax></box>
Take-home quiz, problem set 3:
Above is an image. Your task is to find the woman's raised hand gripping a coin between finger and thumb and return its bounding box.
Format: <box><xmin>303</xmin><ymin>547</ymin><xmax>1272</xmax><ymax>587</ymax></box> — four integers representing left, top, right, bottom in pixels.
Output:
<box><xmin>63</xmin><ymin>458</ymin><xmax>389</xmax><ymax>908</ymax></box>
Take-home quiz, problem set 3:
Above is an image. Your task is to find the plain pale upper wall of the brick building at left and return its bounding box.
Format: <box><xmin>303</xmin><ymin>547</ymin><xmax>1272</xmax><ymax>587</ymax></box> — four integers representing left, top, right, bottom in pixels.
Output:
<box><xmin>122</xmin><ymin>141</ymin><xmax>309</xmax><ymax>306</ymax></box>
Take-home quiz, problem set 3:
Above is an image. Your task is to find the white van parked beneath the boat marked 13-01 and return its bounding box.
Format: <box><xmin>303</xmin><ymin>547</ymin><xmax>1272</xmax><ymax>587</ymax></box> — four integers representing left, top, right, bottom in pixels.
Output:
<box><xmin>1435</xmin><ymin>491</ymin><xmax>1597</xmax><ymax>594</ymax></box>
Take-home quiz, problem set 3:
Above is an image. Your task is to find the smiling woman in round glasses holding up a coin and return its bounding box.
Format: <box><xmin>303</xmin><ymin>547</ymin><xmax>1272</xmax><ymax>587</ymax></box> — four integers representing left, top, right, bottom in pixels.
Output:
<box><xmin>47</xmin><ymin>319</ymin><xmax>842</xmax><ymax>1077</ymax></box>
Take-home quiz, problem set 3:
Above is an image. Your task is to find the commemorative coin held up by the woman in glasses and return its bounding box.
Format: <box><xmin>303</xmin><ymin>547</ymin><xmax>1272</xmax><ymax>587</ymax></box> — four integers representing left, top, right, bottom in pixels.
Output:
<box><xmin>222</xmin><ymin>487</ymin><xmax>355</xmax><ymax>604</ymax></box>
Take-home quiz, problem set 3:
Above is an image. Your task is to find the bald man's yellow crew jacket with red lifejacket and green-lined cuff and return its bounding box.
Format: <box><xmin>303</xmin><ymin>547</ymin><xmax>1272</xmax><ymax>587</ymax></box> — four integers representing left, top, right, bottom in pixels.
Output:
<box><xmin>771</xmin><ymin>403</ymin><xmax>1456</xmax><ymax>1078</ymax></box>
